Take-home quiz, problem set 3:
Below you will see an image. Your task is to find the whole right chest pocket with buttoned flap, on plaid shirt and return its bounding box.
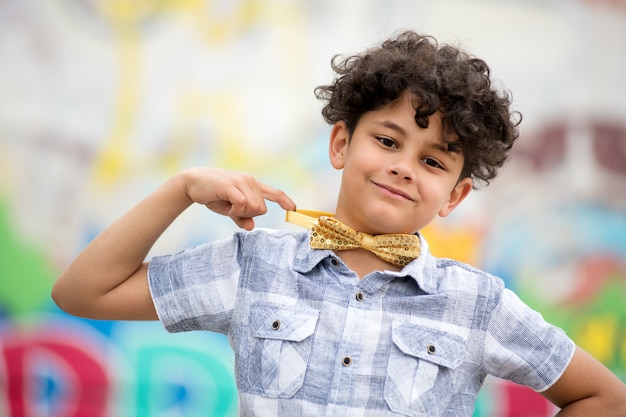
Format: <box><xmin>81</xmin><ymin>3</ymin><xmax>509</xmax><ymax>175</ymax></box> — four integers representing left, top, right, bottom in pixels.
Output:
<box><xmin>384</xmin><ymin>322</ymin><xmax>466</xmax><ymax>417</ymax></box>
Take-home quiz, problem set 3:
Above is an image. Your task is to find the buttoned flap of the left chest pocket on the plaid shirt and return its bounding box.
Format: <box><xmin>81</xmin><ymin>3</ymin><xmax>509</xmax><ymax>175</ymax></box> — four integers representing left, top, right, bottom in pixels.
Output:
<box><xmin>250</xmin><ymin>302</ymin><xmax>319</xmax><ymax>342</ymax></box>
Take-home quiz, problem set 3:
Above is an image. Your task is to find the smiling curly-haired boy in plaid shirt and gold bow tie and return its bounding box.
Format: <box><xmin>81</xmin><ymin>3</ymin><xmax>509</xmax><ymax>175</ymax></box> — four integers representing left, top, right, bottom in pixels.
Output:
<box><xmin>53</xmin><ymin>32</ymin><xmax>626</xmax><ymax>417</ymax></box>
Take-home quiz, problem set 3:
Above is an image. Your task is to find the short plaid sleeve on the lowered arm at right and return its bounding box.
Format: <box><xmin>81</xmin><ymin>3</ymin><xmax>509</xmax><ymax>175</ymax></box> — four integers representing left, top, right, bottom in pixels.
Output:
<box><xmin>484</xmin><ymin>288</ymin><xmax>575</xmax><ymax>392</ymax></box>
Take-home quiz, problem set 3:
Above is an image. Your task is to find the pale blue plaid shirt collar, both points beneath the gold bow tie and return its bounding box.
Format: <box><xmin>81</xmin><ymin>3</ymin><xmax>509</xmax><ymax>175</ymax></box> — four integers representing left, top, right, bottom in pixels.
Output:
<box><xmin>294</xmin><ymin>230</ymin><xmax>438</xmax><ymax>294</ymax></box>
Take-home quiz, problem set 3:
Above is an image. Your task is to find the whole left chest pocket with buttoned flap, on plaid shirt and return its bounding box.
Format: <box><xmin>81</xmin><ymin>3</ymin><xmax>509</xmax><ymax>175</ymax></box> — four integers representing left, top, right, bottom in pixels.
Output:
<box><xmin>246</xmin><ymin>302</ymin><xmax>319</xmax><ymax>398</ymax></box>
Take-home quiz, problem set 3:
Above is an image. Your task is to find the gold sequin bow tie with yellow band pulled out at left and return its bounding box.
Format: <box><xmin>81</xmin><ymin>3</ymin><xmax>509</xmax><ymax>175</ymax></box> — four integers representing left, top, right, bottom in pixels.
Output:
<box><xmin>286</xmin><ymin>210</ymin><xmax>420</xmax><ymax>266</ymax></box>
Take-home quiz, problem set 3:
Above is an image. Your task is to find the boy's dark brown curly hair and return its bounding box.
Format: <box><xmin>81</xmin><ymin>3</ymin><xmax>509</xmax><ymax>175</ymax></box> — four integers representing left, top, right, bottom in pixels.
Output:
<box><xmin>315</xmin><ymin>31</ymin><xmax>522</xmax><ymax>188</ymax></box>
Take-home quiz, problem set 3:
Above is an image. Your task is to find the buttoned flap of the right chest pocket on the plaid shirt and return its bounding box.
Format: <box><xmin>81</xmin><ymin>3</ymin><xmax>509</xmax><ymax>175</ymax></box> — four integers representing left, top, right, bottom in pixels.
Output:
<box><xmin>392</xmin><ymin>322</ymin><xmax>466</xmax><ymax>368</ymax></box>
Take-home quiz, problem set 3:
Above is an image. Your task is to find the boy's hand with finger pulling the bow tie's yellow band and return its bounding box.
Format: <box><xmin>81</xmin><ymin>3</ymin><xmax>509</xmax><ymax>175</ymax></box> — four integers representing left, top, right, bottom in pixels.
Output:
<box><xmin>183</xmin><ymin>168</ymin><xmax>296</xmax><ymax>230</ymax></box>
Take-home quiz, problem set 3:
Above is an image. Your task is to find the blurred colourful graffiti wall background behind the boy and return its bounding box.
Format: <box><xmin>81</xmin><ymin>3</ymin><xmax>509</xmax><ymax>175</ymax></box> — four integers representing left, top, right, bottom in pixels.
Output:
<box><xmin>0</xmin><ymin>0</ymin><xmax>626</xmax><ymax>417</ymax></box>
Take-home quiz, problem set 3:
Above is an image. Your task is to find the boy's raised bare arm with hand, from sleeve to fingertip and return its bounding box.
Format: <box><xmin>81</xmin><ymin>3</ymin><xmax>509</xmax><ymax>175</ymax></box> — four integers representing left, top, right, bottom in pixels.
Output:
<box><xmin>52</xmin><ymin>167</ymin><xmax>296</xmax><ymax>320</ymax></box>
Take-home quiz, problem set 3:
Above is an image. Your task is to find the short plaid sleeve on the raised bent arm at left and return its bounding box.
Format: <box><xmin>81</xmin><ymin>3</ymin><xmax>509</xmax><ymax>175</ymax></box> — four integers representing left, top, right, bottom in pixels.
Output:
<box><xmin>148</xmin><ymin>238</ymin><xmax>240</xmax><ymax>333</ymax></box>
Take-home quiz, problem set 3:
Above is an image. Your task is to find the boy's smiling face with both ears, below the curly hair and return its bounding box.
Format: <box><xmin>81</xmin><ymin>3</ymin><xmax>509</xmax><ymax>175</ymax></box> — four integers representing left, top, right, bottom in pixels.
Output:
<box><xmin>330</xmin><ymin>94</ymin><xmax>472</xmax><ymax>234</ymax></box>
